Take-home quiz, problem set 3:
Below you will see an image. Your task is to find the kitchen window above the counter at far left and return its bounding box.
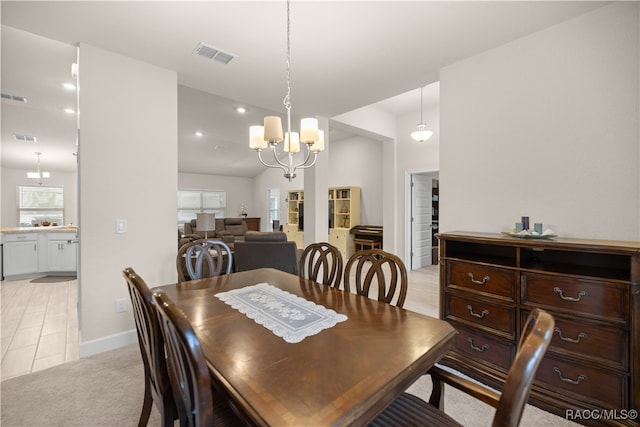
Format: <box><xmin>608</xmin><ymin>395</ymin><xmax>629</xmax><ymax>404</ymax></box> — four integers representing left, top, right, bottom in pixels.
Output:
<box><xmin>17</xmin><ymin>185</ymin><xmax>64</xmax><ymax>227</ymax></box>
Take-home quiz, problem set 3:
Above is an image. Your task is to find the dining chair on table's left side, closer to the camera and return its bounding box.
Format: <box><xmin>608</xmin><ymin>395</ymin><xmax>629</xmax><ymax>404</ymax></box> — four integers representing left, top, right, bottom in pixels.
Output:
<box><xmin>153</xmin><ymin>291</ymin><xmax>244</xmax><ymax>427</ymax></box>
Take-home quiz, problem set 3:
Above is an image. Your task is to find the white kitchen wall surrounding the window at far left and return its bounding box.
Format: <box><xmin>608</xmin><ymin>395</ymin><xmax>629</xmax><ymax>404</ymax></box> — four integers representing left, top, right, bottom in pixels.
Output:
<box><xmin>0</xmin><ymin>167</ymin><xmax>78</xmax><ymax>228</ymax></box>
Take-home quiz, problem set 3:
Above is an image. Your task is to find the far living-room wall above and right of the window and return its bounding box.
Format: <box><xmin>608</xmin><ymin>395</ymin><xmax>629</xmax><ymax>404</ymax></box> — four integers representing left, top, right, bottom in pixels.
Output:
<box><xmin>178</xmin><ymin>173</ymin><xmax>252</xmax><ymax>222</ymax></box>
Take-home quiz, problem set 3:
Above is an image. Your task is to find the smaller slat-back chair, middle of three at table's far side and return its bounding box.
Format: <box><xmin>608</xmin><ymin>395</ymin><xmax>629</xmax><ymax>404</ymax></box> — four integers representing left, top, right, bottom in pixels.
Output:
<box><xmin>298</xmin><ymin>242</ymin><xmax>343</xmax><ymax>289</ymax></box>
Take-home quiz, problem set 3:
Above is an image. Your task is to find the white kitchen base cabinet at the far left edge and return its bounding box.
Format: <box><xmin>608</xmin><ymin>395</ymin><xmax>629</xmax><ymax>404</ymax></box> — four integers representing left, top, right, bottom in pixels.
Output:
<box><xmin>3</xmin><ymin>233</ymin><xmax>38</xmax><ymax>276</ymax></box>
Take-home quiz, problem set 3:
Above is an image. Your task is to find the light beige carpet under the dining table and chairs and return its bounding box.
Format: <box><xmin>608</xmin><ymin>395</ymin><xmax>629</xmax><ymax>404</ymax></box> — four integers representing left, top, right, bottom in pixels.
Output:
<box><xmin>0</xmin><ymin>345</ymin><xmax>577</xmax><ymax>427</ymax></box>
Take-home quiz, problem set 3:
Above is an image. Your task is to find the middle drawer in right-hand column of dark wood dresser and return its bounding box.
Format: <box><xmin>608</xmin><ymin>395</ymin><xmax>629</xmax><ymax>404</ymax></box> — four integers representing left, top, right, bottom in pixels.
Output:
<box><xmin>521</xmin><ymin>310</ymin><xmax>629</xmax><ymax>370</ymax></box>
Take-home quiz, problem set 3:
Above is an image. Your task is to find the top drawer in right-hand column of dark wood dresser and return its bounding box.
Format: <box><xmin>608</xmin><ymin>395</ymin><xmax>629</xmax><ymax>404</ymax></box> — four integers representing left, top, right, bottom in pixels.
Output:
<box><xmin>522</xmin><ymin>273</ymin><xmax>629</xmax><ymax>323</ymax></box>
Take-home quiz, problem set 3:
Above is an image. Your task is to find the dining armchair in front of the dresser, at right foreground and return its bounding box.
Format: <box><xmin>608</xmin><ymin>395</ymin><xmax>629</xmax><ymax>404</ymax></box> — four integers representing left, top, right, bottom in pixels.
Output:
<box><xmin>370</xmin><ymin>309</ymin><xmax>554</xmax><ymax>427</ymax></box>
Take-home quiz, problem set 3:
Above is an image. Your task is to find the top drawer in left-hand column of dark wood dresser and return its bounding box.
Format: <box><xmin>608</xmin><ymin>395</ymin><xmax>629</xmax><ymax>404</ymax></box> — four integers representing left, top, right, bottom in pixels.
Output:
<box><xmin>447</xmin><ymin>261</ymin><xmax>518</xmax><ymax>301</ymax></box>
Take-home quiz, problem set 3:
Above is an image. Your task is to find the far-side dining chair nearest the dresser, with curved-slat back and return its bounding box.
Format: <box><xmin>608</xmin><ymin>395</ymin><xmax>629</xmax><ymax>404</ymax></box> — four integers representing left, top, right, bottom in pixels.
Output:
<box><xmin>343</xmin><ymin>249</ymin><xmax>408</xmax><ymax>308</ymax></box>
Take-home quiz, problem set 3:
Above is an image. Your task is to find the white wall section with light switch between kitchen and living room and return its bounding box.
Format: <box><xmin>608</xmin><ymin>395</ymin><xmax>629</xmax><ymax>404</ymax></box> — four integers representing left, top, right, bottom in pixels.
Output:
<box><xmin>79</xmin><ymin>44</ymin><xmax>178</xmax><ymax>356</ymax></box>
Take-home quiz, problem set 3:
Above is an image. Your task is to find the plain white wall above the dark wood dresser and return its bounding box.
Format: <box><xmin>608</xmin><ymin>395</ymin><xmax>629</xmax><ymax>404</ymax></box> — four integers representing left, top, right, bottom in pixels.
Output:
<box><xmin>440</xmin><ymin>2</ymin><xmax>640</xmax><ymax>244</ymax></box>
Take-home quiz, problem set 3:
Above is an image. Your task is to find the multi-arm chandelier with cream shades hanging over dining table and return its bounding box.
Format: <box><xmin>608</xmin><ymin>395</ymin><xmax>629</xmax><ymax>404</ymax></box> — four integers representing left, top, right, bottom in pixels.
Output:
<box><xmin>249</xmin><ymin>0</ymin><xmax>324</xmax><ymax>181</ymax></box>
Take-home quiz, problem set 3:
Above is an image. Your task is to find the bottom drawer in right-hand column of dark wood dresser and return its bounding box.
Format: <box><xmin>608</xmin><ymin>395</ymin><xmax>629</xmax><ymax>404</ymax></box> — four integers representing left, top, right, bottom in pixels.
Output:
<box><xmin>536</xmin><ymin>353</ymin><xmax>629</xmax><ymax>408</ymax></box>
